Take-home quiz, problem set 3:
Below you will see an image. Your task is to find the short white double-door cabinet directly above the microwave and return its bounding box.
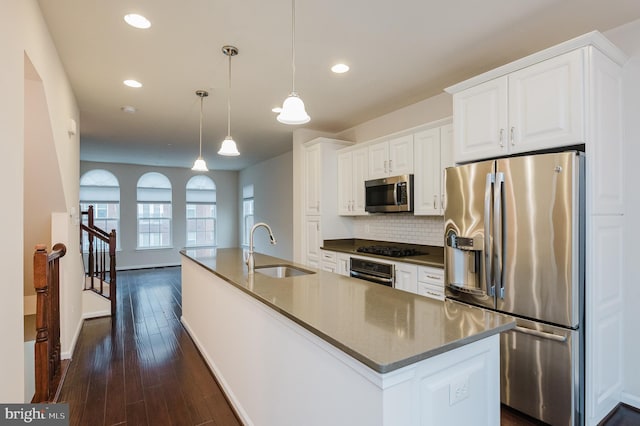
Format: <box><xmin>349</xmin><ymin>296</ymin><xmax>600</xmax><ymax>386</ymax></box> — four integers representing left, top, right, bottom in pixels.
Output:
<box><xmin>368</xmin><ymin>135</ymin><xmax>413</xmax><ymax>179</ymax></box>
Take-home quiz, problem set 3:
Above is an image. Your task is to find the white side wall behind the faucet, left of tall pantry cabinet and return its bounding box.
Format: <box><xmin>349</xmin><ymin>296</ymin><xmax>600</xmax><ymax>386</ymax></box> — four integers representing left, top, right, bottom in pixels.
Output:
<box><xmin>238</xmin><ymin>151</ymin><xmax>293</xmax><ymax>260</ymax></box>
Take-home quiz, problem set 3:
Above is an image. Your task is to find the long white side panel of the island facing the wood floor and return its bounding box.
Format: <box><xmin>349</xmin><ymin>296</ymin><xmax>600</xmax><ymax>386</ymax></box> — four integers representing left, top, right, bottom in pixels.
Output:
<box><xmin>182</xmin><ymin>258</ymin><xmax>382</xmax><ymax>426</ymax></box>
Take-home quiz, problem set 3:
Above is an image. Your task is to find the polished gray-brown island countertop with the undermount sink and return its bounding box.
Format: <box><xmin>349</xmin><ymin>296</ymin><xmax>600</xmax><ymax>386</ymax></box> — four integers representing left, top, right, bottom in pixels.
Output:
<box><xmin>180</xmin><ymin>248</ymin><xmax>515</xmax><ymax>373</ymax></box>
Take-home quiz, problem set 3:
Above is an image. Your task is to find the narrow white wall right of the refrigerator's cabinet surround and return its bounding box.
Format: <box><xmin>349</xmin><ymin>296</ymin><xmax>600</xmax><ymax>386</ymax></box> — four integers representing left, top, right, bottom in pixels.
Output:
<box><xmin>605</xmin><ymin>20</ymin><xmax>640</xmax><ymax>407</ymax></box>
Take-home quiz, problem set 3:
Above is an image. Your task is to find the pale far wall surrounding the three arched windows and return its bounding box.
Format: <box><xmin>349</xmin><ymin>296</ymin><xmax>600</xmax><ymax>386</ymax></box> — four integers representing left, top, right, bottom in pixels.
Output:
<box><xmin>80</xmin><ymin>161</ymin><xmax>239</xmax><ymax>269</ymax></box>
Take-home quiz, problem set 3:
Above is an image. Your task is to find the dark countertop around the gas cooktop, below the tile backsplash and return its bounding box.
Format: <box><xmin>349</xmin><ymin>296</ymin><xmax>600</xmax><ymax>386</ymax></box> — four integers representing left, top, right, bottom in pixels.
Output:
<box><xmin>321</xmin><ymin>238</ymin><xmax>444</xmax><ymax>268</ymax></box>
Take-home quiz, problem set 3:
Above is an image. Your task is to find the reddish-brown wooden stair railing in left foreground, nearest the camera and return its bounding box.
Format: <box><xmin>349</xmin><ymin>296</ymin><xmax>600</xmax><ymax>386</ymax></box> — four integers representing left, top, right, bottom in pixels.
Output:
<box><xmin>31</xmin><ymin>243</ymin><xmax>67</xmax><ymax>403</ymax></box>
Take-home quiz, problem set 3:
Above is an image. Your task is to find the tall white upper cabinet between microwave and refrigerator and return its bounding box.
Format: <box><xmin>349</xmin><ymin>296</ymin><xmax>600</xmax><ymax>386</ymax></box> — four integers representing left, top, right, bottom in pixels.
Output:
<box><xmin>414</xmin><ymin>124</ymin><xmax>453</xmax><ymax>216</ymax></box>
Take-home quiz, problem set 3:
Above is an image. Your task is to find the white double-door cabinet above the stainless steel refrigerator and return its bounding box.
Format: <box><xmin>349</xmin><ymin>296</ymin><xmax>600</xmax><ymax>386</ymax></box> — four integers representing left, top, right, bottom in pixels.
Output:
<box><xmin>453</xmin><ymin>48</ymin><xmax>587</xmax><ymax>162</ymax></box>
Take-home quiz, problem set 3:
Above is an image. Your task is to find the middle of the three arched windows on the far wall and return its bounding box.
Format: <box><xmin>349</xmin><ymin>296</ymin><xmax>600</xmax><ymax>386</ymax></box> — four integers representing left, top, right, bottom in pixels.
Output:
<box><xmin>137</xmin><ymin>172</ymin><xmax>171</xmax><ymax>249</ymax></box>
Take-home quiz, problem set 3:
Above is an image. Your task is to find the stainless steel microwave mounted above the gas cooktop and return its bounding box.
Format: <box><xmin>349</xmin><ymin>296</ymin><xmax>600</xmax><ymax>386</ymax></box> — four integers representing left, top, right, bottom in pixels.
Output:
<box><xmin>364</xmin><ymin>175</ymin><xmax>413</xmax><ymax>213</ymax></box>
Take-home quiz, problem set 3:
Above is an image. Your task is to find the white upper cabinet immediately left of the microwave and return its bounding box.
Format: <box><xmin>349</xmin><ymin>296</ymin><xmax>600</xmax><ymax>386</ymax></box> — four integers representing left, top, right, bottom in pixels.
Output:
<box><xmin>338</xmin><ymin>146</ymin><xmax>368</xmax><ymax>216</ymax></box>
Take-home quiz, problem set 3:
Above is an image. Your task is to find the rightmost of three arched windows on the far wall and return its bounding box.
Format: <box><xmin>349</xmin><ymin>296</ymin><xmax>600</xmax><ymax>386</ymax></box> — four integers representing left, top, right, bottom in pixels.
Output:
<box><xmin>187</xmin><ymin>175</ymin><xmax>216</xmax><ymax>247</ymax></box>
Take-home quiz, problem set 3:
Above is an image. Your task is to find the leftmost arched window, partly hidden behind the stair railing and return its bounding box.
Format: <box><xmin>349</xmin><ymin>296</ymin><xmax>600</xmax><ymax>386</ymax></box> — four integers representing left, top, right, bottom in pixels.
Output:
<box><xmin>80</xmin><ymin>169</ymin><xmax>120</xmax><ymax>248</ymax></box>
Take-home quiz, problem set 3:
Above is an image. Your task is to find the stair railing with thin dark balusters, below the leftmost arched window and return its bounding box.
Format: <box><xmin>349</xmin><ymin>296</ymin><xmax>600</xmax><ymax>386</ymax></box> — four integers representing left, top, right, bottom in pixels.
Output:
<box><xmin>80</xmin><ymin>206</ymin><xmax>116</xmax><ymax>316</ymax></box>
